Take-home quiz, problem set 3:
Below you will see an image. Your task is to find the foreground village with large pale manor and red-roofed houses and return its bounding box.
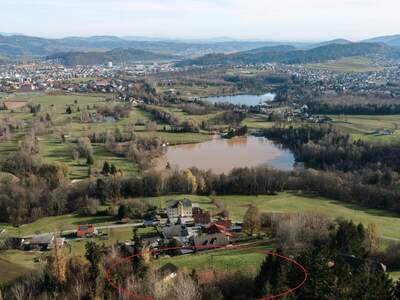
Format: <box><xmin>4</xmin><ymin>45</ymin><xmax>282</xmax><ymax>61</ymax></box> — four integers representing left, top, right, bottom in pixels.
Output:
<box><xmin>9</xmin><ymin>198</ymin><xmax>247</xmax><ymax>266</ymax></box>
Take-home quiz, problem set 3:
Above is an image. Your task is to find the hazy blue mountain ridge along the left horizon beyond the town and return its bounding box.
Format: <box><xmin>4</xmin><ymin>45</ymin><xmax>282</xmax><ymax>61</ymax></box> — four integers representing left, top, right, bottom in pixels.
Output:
<box><xmin>0</xmin><ymin>35</ymin><xmax>302</xmax><ymax>59</ymax></box>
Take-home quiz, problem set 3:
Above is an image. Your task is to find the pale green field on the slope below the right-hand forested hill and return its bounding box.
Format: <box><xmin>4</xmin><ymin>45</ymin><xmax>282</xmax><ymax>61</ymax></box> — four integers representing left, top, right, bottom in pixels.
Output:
<box><xmin>306</xmin><ymin>57</ymin><xmax>383</xmax><ymax>73</ymax></box>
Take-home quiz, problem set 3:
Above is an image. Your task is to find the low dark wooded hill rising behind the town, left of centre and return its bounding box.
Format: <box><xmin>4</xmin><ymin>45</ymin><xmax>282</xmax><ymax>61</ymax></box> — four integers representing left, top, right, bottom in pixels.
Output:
<box><xmin>47</xmin><ymin>48</ymin><xmax>178</xmax><ymax>66</ymax></box>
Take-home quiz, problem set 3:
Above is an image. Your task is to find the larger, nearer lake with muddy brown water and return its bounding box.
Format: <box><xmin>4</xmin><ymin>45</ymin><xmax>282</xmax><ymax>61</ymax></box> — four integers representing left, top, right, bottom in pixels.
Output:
<box><xmin>163</xmin><ymin>136</ymin><xmax>295</xmax><ymax>174</ymax></box>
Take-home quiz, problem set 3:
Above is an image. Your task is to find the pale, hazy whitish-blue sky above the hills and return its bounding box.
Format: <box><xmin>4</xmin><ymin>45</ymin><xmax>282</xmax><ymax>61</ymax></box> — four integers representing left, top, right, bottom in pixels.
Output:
<box><xmin>0</xmin><ymin>0</ymin><xmax>400</xmax><ymax>41</ymax></box>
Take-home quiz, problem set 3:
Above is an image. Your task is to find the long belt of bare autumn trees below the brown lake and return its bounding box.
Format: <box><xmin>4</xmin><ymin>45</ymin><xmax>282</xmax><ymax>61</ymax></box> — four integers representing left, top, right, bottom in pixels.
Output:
<box><xmin>0</xmin><ymin>158</ymin><xmax>400</xmax><ymax>225</ymax></box>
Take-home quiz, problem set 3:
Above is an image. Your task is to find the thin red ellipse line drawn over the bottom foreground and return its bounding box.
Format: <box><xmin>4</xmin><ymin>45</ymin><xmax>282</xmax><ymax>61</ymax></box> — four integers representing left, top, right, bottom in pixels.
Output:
<box><xmin>104</xmin><ymin>245</ymin><xmax>308</xmax><ymax>300</ymax></box>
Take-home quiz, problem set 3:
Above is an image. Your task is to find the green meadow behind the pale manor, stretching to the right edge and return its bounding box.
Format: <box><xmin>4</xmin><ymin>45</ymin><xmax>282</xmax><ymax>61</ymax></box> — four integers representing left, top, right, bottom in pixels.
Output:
<box><xmin>138</xmin><ymin>192</ymin><xmax>400</xmax><ymax>239</ymax></box>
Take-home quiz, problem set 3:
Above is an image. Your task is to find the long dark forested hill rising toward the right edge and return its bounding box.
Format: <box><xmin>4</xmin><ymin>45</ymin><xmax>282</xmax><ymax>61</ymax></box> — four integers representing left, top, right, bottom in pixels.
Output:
<box><xmin>177</xmin><ymin>43</ymin><xmax>400</xmax><ymax>66</ymax></box>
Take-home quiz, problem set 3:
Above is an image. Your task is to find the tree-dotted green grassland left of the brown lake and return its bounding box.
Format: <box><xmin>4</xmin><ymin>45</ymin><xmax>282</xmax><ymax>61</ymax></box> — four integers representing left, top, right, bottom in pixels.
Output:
<box><xmin>0</xmin><ymin>93</ymin><xmax>213</xmax><ymax>180</ymax></box>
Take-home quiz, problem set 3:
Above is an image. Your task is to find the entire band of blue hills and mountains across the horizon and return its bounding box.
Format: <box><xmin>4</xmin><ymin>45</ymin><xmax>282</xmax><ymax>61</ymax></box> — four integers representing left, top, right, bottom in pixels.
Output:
<box><xmin>0</xmin><ymin>33</ymin><xmax>400</xmax><ymax>65</ymax></box>
